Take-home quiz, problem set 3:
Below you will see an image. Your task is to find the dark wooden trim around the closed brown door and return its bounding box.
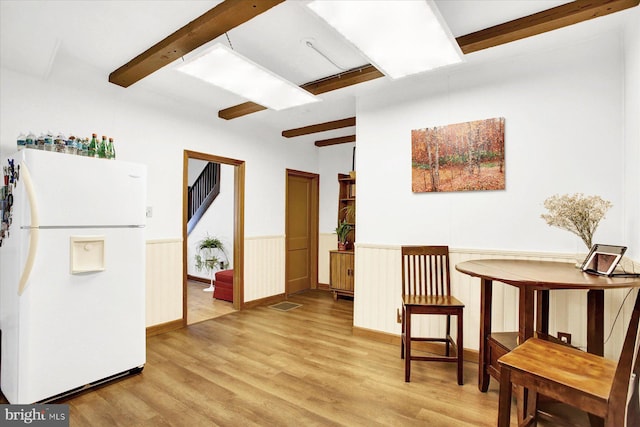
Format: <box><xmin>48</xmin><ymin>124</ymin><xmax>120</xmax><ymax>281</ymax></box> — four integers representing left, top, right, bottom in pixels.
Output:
<box><xmin>284</xmin><ymin>169</ymin><xmax>320</xmax><ymax>295</ymax></box>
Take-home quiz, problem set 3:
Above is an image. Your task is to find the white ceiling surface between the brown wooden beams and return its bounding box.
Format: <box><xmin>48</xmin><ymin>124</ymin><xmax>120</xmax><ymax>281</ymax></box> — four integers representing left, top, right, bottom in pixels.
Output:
<box><xmin>0</xmin><ymin>0</ymin><xmax>624</xmax><ymax>142</ymax></box>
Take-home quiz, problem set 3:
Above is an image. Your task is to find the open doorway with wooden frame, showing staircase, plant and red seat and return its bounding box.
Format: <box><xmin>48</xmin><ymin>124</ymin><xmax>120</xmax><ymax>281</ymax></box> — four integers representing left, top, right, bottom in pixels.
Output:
<box><xmin>182</xmin><ymin>150</ymin><xmax>244</xmax><ymax>325</ymax></box>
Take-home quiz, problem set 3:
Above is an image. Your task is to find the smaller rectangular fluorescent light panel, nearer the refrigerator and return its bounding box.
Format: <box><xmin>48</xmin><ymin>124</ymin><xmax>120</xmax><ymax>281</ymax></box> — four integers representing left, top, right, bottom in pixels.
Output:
<box><xmin>177</xmin><ymin>43</ymin><xmax>319</xmax><ymax>110</ymax></box>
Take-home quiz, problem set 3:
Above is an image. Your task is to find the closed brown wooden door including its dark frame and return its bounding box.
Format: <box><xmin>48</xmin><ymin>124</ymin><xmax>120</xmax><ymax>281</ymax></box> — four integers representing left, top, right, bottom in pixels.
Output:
<box><xmin>285</xmin><ymin>169</ymin><xmax>320</xmax><ymax>295</ymax></box>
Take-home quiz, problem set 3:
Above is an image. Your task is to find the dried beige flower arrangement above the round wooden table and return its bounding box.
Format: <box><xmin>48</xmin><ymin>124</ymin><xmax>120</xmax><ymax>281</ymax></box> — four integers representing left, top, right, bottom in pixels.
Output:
<box><xmin>540</xmin><ymin>193</ymin><xmax>613</xmax><ymax>248</ymax></box>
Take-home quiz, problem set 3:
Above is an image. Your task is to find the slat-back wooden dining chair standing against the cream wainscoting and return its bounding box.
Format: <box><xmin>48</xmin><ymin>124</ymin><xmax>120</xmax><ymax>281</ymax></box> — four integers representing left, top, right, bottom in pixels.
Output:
<box><xmin>400</xmin><ymin>246</ymin><xmax>464</xmax><ymax>385</ymax></box>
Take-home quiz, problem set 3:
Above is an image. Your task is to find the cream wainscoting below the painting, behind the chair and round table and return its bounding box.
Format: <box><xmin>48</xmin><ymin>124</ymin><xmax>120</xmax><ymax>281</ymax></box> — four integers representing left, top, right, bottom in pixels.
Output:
<box><xmin>354</xmin><ymin>244</ymin><xmax>635</xmax><ymax>359</ymax></box>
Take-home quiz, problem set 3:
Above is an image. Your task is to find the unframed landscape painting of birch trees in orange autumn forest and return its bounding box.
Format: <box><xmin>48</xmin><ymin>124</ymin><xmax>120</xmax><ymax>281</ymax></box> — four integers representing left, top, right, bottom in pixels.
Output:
<box><xmin>411</xmin><ymin>117</ymin><xmax>505</xmax><ymax>193</ymax></box>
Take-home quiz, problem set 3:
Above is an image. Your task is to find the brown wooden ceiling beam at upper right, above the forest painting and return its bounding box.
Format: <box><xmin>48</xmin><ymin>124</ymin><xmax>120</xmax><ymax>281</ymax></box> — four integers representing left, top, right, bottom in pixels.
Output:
<box><xmin>456</xmin><ymin>0</ymin><xmax>640</xmax><ymax>54</ymax></box>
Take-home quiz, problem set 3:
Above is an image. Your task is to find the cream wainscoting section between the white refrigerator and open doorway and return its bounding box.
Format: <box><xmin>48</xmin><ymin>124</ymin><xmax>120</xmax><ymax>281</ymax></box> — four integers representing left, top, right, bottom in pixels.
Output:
<box><xmin>146</xmin><ymin>239</ymin><xmax>182</xmax><ymax>327</ymax></box>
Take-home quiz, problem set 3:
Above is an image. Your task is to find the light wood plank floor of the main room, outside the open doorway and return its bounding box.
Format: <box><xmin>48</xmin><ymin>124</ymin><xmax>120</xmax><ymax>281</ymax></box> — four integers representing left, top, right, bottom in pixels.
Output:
<box><xmin>61</xmin><ymin>291</ymin><xmax>515</xmax><ymax>427</ymax></box>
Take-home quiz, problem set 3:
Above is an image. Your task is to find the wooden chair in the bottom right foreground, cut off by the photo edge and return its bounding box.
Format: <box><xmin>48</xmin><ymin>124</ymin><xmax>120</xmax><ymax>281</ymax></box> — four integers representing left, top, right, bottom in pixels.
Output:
<box><xmin>498</xmin><ymin>292</ymin><xmax>640</xmax><ymax>427</ymax></box>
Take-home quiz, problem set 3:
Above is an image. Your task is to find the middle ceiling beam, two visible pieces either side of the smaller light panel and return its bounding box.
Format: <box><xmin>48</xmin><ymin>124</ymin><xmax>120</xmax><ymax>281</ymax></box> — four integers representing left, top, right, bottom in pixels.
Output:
<box><xmin>218</xmin><ymin>64</ymin><xmax>384</xmax><ymax>120</ymax></box>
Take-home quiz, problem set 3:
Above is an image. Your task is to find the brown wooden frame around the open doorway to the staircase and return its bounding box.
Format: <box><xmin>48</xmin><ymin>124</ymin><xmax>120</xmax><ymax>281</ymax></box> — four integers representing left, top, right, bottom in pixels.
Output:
<box><xmin>182</xmin><ymin>150</ymin><xmax>245</xmax><ymax>326</ymax></box>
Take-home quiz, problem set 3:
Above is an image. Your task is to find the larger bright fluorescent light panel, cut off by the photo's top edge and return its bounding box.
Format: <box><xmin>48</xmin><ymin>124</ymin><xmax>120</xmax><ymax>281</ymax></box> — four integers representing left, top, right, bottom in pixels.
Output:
<box><xmin>308</xmin><ymin>0</ymin><xmax>462</xmax><ymax>79</ymax></box>
